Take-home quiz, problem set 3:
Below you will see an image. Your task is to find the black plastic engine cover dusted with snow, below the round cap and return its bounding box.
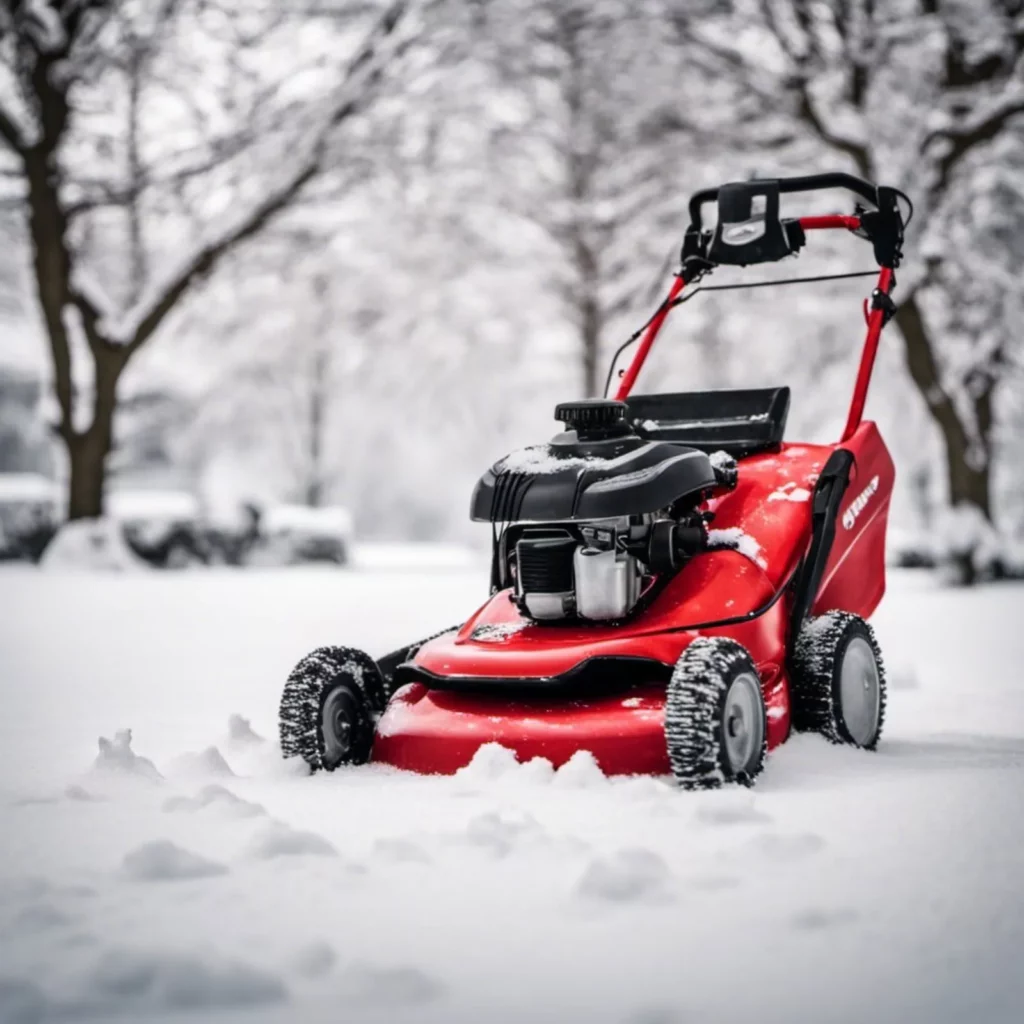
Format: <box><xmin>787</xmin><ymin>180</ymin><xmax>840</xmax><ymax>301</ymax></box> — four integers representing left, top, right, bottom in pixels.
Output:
<box><xmin>470</xmin><ymin>431</ymin><xmax>716</xmax><ymax>522</ymax></box>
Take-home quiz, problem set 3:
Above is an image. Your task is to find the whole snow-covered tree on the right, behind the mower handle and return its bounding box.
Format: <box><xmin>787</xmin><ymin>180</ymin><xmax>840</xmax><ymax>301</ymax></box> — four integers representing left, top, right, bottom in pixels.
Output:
<box><xmin>674</xmin><ymin>0</ymin><xmax>1024</xmax><ymax>577</ymax></box>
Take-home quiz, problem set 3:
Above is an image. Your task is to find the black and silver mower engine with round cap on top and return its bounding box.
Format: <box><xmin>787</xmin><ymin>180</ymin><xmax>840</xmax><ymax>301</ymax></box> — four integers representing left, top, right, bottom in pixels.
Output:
<box><xmin>472</xmin><ymin>400</ymin><xmax>735</xmax><ymax>622</ymax></box>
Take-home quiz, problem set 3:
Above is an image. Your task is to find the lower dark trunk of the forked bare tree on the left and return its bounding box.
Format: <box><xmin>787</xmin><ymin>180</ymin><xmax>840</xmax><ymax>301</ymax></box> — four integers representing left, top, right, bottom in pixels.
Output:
<box><xmin>65</xmin><ymin>349</ymin><xmax>127</xmax><ymax>519</ymax></box>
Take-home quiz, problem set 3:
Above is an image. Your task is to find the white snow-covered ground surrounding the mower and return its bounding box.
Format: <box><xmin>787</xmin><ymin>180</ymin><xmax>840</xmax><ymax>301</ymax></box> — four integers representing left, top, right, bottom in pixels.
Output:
<box><xmin>0</xmin><ymin>559</ymin><xmax>1024</xmax><ymax>1024</ymax></box>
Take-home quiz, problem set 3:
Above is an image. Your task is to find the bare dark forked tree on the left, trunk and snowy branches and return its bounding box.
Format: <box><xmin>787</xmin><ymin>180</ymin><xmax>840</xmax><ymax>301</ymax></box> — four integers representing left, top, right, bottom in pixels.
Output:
<box><xmin>0</xmin><ymin>0</ymin><xmax>408</xmax><ymax>518</ymax></box>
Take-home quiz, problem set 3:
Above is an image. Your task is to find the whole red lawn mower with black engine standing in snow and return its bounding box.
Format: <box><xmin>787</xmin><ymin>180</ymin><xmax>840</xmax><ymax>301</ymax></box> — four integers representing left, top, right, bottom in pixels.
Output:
<box><xmin>281</xmin><ymin>173</ymin><xmax>909</xmax><ymax>788</ymax></box>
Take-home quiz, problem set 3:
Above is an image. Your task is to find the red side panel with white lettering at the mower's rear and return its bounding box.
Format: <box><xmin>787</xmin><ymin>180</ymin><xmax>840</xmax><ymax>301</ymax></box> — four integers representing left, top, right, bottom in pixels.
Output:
<box><xmin>812</xmin><ymin>422</ymin><xmax>896</xmax><ymax>618</ymax></box>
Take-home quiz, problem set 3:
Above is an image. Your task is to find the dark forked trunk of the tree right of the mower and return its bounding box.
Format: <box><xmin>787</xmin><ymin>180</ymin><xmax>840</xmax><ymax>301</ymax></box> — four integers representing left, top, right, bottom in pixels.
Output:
<box><xmin>896</xmin><ymin>295</ymin><xmax>992</xmax><ymax>584</ymax></box>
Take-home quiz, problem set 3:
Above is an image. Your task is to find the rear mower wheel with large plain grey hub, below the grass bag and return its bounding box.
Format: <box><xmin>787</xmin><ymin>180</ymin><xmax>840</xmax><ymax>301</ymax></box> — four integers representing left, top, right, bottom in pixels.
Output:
<box><xmin>791</xmin><ymin>611</ymin><xmax>886</xmax><ymax>751</ymax></box>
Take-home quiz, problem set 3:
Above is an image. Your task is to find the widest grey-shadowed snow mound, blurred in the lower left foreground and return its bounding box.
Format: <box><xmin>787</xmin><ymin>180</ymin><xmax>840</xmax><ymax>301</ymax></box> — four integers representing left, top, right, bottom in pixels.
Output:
<box><xmin>76</xmin><ymin>947</ymin><xmax>288</xmax><ymax>1020</ymax></box>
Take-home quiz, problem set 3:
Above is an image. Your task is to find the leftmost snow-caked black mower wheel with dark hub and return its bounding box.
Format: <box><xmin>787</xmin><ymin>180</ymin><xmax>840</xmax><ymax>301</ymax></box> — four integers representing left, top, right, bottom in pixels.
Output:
<box><xmin>279</xmin><ymin>647</ymin><xmax>387</xmax><ymax>771</ymax></box>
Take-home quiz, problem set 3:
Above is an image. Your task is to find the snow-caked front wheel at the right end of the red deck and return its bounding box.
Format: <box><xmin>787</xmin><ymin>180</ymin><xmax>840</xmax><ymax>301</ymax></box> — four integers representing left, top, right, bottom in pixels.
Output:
<box><xmin>665</xmin><ymin>637</ymin><xmax>768</xmax><ymax>790</ymax></box>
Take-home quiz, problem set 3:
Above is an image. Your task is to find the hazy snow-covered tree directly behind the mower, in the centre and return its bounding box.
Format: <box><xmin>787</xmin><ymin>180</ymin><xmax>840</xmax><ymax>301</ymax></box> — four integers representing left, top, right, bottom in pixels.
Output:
<box><xmin>462</xmin><ymin>0</ymin><xmax>745</xmax><ymax>395</ymax></box>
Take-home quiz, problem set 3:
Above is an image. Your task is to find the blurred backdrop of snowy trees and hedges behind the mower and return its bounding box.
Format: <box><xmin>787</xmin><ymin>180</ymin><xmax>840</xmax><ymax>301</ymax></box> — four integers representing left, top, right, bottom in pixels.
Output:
<box><xmin>0</xmin><ymin>0</ymin><xmax>1024</xmax><ymax>583</ymax></box>
